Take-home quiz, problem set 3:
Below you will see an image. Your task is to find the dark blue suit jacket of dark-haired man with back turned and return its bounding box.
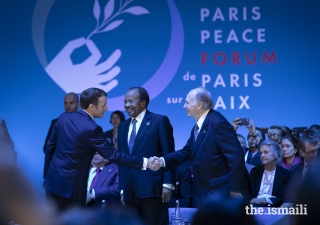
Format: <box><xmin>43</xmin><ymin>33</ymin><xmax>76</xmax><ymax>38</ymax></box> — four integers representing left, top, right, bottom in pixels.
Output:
<box><xmin>43</xmin><ymin>110</ymin><xmax>143</xmax><ymax>203</ymax></box>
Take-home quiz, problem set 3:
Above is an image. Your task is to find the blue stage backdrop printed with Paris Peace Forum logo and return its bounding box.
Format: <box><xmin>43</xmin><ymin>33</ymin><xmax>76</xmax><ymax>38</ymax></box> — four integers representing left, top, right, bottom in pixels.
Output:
<box><xmin>0</xmin><ymin>0</ymin><xmax>320</xmax><ymax>197</ymax></box>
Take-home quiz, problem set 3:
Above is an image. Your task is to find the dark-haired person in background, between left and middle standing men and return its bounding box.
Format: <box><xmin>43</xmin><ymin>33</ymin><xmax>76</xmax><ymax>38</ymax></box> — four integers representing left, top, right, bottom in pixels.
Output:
<box><xmin>104</xmin><ymin>110</ymin><xmax>125</xmax><ymax>149</ymax></box>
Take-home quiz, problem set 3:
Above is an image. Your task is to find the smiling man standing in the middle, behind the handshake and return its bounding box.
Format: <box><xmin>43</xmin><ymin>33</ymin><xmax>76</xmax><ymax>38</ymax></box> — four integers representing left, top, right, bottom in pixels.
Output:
<box><xmin>118</xmin><ymin>87</ymin><xmax>174</xmax><ymax>225</ymax></box>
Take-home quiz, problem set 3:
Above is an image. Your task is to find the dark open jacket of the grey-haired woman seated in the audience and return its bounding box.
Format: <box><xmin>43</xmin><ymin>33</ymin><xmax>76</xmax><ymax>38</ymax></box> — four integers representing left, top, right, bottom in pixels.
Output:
<box><xmin>250</xmin><ymin>165</ymin><xmax>290</xmax><ymax>206</ymax></box>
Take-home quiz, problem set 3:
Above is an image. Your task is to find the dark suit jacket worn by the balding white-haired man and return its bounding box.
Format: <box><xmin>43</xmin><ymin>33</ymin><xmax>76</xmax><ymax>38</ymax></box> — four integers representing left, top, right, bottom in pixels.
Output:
<box><xmin>164</xmin><ymin>109</ymin><xmax>250</xmax><ymax>200</ymax></box>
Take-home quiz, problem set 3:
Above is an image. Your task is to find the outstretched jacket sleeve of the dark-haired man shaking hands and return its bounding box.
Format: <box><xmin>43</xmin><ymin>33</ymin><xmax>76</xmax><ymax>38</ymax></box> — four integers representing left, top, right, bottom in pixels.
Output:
<box><xmin>90</xmin><ymin>126</ymin><xmax>143</xmax><ymax>170</ymax></box>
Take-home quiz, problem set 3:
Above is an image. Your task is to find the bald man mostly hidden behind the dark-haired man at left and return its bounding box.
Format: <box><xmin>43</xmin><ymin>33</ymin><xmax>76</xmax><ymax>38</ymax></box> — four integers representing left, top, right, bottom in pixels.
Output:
<box><xmin>43</xmin><ymin>92</ymin><xmax>79</xmax><ymax>153</ymax></box>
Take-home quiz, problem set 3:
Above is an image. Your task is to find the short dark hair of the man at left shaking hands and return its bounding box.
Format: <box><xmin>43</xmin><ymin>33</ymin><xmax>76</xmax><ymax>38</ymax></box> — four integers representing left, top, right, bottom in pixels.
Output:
<box><xmin>80</xmin><ymin>88</ymin><xmax>107</xmax><ymax>109</ymax></box>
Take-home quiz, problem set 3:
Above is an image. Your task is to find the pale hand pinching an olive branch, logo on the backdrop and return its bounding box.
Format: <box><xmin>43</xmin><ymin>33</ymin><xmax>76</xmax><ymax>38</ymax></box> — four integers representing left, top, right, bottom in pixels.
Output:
<box><xmin>45</xmin><ymin>0</ymin><xmax>149</xmax><ymax>93</ymax></box>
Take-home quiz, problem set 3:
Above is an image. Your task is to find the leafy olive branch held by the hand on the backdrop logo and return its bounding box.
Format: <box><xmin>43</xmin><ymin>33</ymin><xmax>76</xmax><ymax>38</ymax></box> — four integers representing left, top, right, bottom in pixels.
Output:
<box><xmin>87</xmin><ymin>0</ymin><xmax>149</xmax><ymax>39</ymax></box>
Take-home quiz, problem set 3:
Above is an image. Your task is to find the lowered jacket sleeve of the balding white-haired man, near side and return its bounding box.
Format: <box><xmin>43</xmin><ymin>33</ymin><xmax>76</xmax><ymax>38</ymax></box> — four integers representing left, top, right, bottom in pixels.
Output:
<box><xmin>215</xmin><ymin>120</ymin><xmax>245</xmax><ymax>192</ymax></box>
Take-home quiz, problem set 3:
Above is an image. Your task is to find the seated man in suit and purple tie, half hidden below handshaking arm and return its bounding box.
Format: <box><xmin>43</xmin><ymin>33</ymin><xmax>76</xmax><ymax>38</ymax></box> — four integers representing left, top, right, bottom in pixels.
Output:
<box><xmin>87</xmin><ymin>152</ymin><xmax>120</xmax><ymax>212</ymax></box>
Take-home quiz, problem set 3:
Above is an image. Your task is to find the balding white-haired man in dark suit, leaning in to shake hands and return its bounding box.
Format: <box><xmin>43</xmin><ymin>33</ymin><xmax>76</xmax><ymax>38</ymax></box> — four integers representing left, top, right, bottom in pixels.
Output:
<box><xmin>154</xmin><ymin>88</ymin><xmax>250</xmax><ymax>202</ymax></box>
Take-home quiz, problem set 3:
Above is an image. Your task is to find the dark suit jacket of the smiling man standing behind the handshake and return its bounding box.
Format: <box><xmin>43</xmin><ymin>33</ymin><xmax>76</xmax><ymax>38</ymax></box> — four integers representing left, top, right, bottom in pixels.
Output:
<box><xmin>118</xmin><ymin>110</ymin><xmax>174</xmax><ymax>201</ymax></box>
